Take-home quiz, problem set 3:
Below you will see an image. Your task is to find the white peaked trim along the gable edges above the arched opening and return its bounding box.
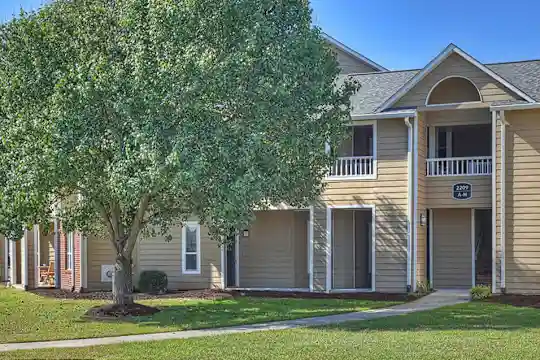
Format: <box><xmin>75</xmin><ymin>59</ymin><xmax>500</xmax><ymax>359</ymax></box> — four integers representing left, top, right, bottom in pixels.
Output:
<box><xmin>375</xmin><ymin>44</ymin><xmax>534</xmax><ymax>112</ymax></box>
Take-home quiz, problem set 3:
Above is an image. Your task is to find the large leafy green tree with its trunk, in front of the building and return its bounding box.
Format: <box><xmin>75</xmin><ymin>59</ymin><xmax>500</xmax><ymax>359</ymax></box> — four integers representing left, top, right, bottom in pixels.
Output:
<box><xmin>0</xmin><ymin>0</ymin><xmax>353</xmax><ymax>305</ymax></box>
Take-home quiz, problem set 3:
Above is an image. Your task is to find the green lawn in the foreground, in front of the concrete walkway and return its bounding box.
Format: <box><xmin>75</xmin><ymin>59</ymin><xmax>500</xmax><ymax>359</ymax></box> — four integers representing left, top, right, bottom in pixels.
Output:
<box><xmin>0</xmin><ymin>303</ymin><xmax>540</xmax><ymax>360</ymax></box>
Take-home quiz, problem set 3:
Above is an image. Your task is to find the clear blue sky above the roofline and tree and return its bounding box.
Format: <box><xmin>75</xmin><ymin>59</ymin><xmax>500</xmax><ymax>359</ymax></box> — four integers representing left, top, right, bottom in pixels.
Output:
<box><xmin>4</xmin><ymin>0</ymin><xmax>540</xmax><ymax>69</ymax></box>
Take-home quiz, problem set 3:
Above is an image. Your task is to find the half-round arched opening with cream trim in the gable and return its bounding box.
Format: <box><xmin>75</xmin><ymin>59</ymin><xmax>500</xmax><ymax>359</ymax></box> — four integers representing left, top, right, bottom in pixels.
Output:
<box><xmin>426</xmin><ymin>76</ymin><xmax>482</xmax><ymax>105</ymax></box>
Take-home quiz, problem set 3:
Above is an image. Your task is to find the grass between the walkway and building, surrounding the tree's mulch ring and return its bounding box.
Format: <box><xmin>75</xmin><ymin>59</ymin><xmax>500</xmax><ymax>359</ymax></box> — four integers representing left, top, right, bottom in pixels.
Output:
<box><xmin>0</xmin><ymin>288</ymin><xmax>395</xmax><ymax>343</ymax></box>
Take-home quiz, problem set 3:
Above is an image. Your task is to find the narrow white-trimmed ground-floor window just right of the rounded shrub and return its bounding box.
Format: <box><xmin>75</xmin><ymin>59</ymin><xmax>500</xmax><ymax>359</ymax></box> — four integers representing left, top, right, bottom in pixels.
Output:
<box><xmin>182</xmin><ymin>221</ymin><xmax>201</xmax><ymax>274</ymax></box>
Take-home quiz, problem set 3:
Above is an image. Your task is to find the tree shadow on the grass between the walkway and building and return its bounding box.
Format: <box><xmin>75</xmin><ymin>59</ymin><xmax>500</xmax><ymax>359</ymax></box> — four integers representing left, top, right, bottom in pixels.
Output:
<box><xmin>79</xmin><ymin>298</ymin><xmax>393</xmax><ymax>330</ymax></box>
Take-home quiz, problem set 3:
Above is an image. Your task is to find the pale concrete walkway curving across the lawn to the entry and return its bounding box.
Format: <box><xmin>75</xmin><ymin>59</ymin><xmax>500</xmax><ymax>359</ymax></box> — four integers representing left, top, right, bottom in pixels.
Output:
<box><xmin>0</xmin><ymin>290</ymin><xmax>469</xmax><ymax>352</ymax></box>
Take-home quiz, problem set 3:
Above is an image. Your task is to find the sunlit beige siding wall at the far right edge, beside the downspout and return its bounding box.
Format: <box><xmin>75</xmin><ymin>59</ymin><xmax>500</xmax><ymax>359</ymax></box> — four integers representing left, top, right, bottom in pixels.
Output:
<box><xmin>497</xmin><ymin>110</ymin><xmax>540</xmax><ymax>293</ymax></box>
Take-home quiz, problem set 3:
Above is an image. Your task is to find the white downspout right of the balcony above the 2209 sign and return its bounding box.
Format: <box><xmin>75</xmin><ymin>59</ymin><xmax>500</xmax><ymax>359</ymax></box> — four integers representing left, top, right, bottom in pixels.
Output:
<box><xmin>491</xmin><ymin>111</ymin><xmax>497</xmax><ymax>293</ymax></box>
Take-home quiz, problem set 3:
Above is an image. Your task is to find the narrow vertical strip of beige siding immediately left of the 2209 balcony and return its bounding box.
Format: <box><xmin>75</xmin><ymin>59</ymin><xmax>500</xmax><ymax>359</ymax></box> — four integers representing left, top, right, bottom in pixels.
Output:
<box><xmin>411</xmin><ymin>113</ymin><xmax>427</xmax><ymax>285</ymax></box>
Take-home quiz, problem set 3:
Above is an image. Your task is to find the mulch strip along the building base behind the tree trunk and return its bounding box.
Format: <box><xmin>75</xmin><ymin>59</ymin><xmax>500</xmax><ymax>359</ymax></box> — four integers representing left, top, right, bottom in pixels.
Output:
<box><xmin>32</xmin><ymin>289</ymin><xmax>233</xmax><ymax>301</ymax></box>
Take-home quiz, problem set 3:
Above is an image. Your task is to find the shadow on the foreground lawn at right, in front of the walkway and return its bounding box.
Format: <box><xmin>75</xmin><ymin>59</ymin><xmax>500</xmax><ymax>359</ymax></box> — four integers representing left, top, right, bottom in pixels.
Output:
<box><xmin>317</xmin><ymin>303</ymin><xmax>540</xmax><ymax>332</ymax></box>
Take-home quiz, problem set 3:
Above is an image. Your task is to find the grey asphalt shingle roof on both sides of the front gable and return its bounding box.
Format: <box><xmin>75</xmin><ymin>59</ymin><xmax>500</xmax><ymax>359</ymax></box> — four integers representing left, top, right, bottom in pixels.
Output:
<box><xmin>344</xmin><ymin>60</ymin><xmax>540</xmax><ymax>114</ymax></box>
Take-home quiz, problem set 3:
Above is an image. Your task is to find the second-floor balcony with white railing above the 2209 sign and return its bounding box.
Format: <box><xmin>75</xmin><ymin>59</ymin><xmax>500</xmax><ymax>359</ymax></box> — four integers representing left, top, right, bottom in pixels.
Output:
<box><xmin>426</xmin><ymin>124</ymin><xmax>493</xmax><ymax>176</ymax></box>
